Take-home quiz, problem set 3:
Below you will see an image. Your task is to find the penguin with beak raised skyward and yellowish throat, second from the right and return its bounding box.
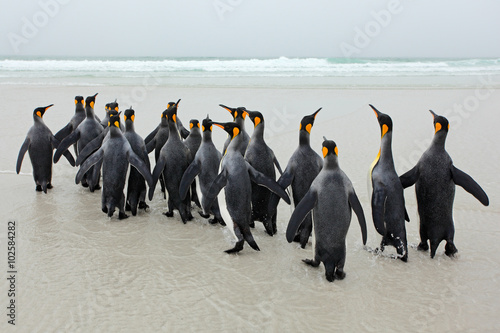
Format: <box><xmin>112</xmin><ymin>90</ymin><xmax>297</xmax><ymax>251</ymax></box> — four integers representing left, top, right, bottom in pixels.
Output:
<box><xmin>370</xmin><ymin>104</ymin><xmax>410</xmax><ymax>262</ymax></box>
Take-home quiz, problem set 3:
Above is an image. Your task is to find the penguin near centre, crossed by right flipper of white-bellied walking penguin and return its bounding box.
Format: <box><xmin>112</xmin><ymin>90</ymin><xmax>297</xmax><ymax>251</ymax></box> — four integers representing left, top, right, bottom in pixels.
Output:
<box><xmin>244</xmin><ymin>110</ymin><xmax>283</xmax><ymax>236</ymax></box>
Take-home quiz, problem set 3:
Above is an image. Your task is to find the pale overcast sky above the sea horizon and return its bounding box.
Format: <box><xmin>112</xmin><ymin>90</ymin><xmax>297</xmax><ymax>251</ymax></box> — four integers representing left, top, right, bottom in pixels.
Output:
<box><xmin>0</xmin><ymin>0</ymin><xmax>500</xmax><ymax>58</ymax></box>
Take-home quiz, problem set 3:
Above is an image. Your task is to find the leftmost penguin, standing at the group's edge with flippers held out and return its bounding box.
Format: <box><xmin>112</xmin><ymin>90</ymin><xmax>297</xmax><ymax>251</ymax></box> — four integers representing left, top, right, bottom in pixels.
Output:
<box><xmin>16</xmin><ymin>104</ymin><xmax>75</xmax><ymax>193</ymax></box>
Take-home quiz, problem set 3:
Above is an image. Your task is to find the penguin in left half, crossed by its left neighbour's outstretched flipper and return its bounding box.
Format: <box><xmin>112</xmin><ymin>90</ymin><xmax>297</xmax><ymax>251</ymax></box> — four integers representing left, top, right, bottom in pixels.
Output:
<box><xmin>123</xmin><ymin>107</ymin><xmax>151</xmax><ymax>216</ymax></box>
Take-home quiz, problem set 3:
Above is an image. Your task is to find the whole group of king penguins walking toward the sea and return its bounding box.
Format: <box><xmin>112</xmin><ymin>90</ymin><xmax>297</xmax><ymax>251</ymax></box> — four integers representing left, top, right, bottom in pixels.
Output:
<box><xmin>16</xmin><ymin>94</ymin><xmax>489</xmax><ymax>281</ymax></box>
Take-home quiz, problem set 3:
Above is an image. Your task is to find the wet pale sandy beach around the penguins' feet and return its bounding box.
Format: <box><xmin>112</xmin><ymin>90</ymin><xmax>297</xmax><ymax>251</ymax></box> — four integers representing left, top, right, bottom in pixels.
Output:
<box><xmin>0</xmin><ymin>78</ymin><xmax>500</xmax><ymax>332</ymax></box>
